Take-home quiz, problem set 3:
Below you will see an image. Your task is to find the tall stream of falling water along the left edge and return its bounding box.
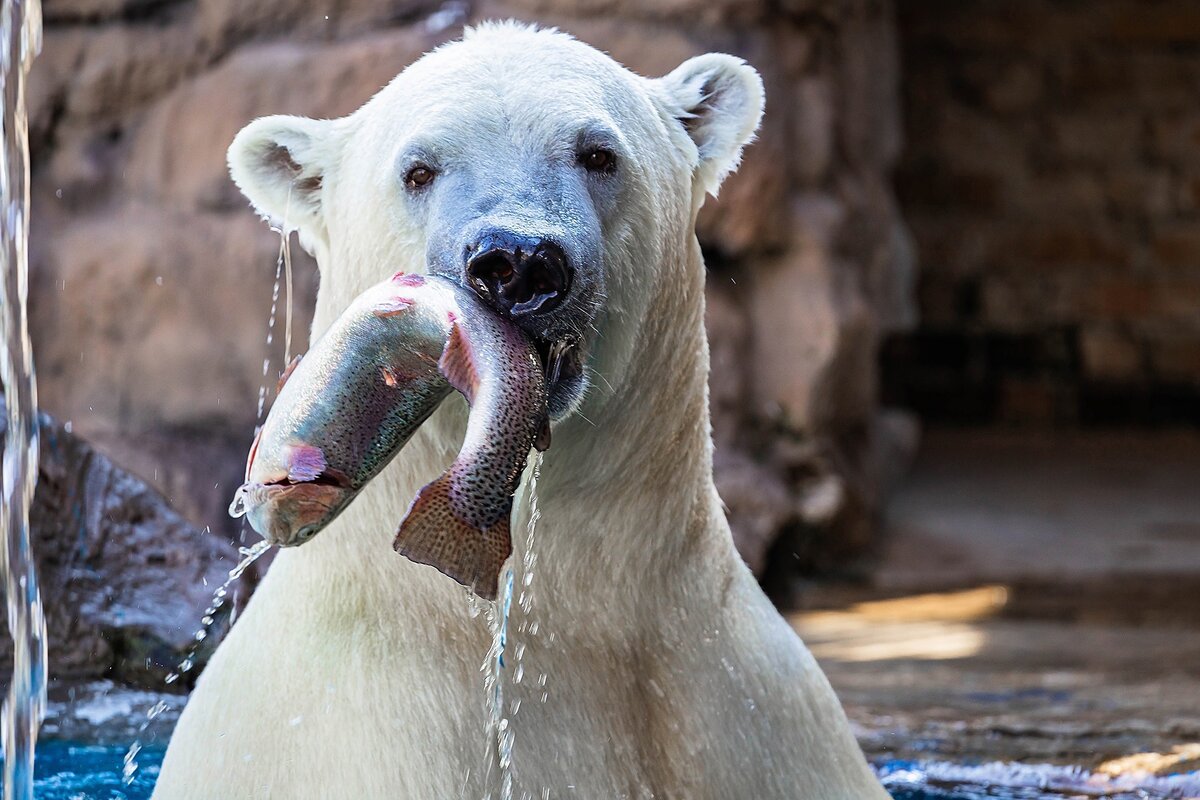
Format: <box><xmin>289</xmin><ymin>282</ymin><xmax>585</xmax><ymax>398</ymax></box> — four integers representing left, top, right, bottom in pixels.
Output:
<box><xmin>0</xmin><ymin>0</ymin><xmax>46</xmax><ymax>800</ymax></box>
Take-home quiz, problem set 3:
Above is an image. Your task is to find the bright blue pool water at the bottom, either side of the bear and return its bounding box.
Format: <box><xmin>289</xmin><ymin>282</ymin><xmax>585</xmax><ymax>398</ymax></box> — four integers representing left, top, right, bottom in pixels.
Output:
<box><xmin>16</xmin><ymin>740</ymin><xmax>1196</xmax><ymax>800</ymax></box>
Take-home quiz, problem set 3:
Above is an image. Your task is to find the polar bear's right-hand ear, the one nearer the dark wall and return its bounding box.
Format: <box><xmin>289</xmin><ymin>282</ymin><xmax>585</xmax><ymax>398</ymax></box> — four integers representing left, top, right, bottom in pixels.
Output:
<box><xmin>654</xmin><ymin>53</ymin><xmax>764</xmax><ymax>194</ymax></box>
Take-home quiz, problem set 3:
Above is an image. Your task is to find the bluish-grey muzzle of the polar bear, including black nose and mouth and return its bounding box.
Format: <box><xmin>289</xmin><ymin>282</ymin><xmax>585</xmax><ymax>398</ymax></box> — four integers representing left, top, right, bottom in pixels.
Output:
<box><xmin>422</xmin><ymin>154</ymin><xmax>607</xmax><ymax>420</ymax></box>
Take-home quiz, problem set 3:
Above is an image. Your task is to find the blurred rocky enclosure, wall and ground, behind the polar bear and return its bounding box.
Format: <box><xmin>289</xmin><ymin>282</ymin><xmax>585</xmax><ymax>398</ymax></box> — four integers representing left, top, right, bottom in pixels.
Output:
<box><xmin>9</xmin><ymin>0</ymin><xmax>1200</xmax><ymax>777</ymax></box>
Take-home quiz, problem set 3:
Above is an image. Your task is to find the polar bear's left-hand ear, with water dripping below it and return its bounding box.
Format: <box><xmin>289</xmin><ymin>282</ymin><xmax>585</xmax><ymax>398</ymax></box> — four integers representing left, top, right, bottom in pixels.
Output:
<box><xmin>229</xmin><ymin>116</ymin><xmax>336</xmax><ymax>235</ymax></box>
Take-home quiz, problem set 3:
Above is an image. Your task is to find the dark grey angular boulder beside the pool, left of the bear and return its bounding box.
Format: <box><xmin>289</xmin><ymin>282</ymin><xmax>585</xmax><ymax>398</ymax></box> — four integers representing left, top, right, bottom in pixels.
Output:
<box><xmin>0</xmin><ymin>410</ymin><xmax>238</xmax><ymax>690</ymax></box>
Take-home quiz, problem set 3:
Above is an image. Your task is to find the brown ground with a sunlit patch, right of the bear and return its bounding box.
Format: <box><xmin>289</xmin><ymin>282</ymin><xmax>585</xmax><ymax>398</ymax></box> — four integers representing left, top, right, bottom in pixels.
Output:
<box><xmin>791</xmin><ymin>433</ymin><xmax>1200</xmax><ymax>771</ymax></box>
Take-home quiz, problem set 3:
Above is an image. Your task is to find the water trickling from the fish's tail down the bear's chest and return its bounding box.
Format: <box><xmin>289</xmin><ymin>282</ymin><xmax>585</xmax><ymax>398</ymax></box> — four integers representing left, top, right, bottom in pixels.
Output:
<box><xmin>469</xmin><ymin>452</ymin><xmax>545</xmax><ymax>800</ymax></box>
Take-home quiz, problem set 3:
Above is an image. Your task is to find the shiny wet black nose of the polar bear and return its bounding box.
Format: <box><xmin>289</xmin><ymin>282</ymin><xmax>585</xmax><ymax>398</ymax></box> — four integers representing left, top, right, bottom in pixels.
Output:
<box><xmin>467</xmin><ymin>230</ymin><xmax>571</xmax><ymax>317</ymax></box>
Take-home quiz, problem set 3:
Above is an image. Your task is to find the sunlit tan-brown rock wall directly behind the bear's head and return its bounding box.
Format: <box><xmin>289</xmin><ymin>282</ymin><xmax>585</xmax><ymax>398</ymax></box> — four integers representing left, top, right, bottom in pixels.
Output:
<box><xmin>31</xmin><ymin>0</ymin><xmax>912</xmax><ymax>587</ymax></box>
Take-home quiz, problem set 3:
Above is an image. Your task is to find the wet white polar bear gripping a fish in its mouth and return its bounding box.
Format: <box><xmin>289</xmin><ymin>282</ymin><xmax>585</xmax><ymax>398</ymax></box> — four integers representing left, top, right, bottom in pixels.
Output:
<box><xmin>155</xmin><ymin>23</ymin><xmax>888</xmax><ymax>800</ymax></box>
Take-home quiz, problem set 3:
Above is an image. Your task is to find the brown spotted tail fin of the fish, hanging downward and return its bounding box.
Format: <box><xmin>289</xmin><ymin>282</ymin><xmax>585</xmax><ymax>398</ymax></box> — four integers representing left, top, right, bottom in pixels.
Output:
<box><xmin>392</xmin><ymin>473</ymin><xmax>512</xmax><ymax>600</ymax></box>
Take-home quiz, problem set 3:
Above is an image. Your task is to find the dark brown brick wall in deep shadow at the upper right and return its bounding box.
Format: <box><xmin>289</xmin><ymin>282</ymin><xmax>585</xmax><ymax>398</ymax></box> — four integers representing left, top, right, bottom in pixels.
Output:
<box><xmin>886</xmin><ymin>0</ymin><xmax>1200</xmax><ymax>426</ymax></box>
